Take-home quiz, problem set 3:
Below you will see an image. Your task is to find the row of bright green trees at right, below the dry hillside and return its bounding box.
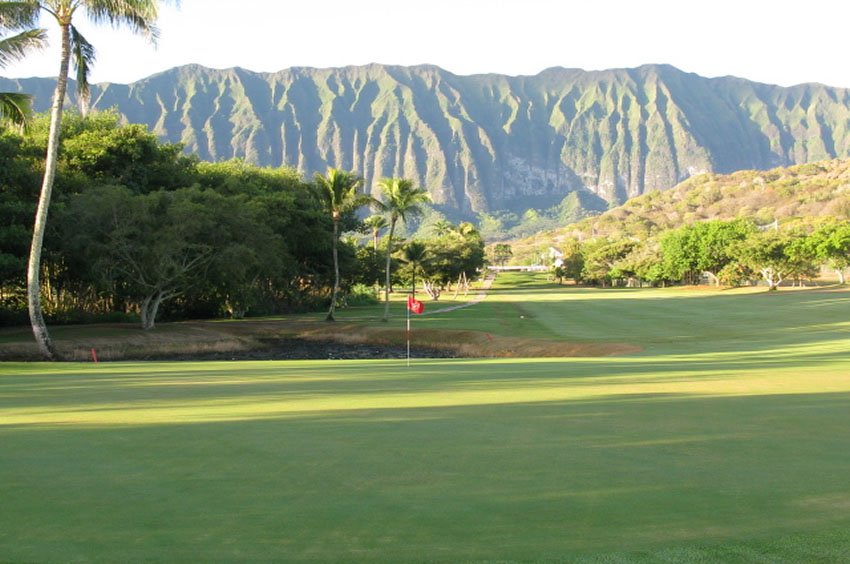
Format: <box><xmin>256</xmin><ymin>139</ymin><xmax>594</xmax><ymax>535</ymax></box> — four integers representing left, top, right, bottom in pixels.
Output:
<box><xmin>552</xmin><ymin>218</ymin><xmax>850</xmax><ymax>290</ymax></box>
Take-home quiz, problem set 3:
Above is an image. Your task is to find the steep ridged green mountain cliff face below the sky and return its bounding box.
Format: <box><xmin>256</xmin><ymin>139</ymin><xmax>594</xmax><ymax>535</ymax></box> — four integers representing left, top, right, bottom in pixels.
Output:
<box><xmin>0</xmin><ymin>65</ymin><xmax>850</xmax><ymax>213</ymax></box>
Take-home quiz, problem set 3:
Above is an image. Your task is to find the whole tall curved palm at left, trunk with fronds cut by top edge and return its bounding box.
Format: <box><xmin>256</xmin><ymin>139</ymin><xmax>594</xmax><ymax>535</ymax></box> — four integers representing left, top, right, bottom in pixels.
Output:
<box><xmin>24</xmin><ymin>0</ymin><xmax>167</xmax><ymax>360</ymax></box>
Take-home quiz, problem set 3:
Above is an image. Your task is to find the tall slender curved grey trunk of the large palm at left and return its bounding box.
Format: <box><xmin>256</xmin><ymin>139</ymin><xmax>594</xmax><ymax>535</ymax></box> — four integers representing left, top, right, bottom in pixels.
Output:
<box><xmin>27</xmin><ymin>25</ymin><xmax>71</xmax><ymax>360</ymax></box>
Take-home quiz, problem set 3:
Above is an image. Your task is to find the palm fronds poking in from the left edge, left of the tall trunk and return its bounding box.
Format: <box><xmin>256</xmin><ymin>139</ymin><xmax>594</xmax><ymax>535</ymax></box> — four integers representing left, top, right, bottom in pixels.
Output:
<box><xmin>0</xmin><ymin>2</ymin><xmax>47</xmax><ymax>127</ymax></box>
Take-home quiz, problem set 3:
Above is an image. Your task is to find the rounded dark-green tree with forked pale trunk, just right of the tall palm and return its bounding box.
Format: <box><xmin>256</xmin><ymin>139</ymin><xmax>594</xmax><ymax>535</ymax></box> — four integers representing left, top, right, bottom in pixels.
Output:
<box><xmin>56</xmin><ymin>186</ymin><xmax>232</xmax><ymax>330</ymax></box>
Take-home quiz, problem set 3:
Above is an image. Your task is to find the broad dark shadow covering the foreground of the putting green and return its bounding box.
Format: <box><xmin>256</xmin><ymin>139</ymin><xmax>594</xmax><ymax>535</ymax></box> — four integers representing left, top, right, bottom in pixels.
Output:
<box><xmin>0</xmin><ymin>386</ymin><xmax>850</xmax><ymax>561</ymax></box>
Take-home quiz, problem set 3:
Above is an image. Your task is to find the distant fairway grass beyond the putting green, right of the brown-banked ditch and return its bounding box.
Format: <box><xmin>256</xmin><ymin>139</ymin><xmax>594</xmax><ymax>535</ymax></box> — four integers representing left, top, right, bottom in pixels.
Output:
<box><xmin>420</xmin><ymin>273</ymin><xmax>850</xmax><ymax>356</ymax></box>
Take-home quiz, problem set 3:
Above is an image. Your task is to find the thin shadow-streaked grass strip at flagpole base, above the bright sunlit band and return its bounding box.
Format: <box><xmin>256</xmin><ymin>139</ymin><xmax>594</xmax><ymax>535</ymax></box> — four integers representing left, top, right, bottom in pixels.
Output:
<box><xmin>0</xmin><ymin>339</ymin><xmax>850</xmax><ymax>408</ymax></box>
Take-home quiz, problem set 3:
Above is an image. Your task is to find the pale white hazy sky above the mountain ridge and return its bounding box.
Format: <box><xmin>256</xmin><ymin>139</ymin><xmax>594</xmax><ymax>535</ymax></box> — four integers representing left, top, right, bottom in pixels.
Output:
<box><xmin>6</xmin><ymin>0</ymin><xmax>850</xmax><ymax>87</ymax></box>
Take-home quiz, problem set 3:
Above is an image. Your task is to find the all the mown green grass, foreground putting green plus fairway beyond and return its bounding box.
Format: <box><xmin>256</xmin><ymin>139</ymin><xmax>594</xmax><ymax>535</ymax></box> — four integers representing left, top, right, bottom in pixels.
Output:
<box><xmin>0</xmin><ymin>277</ymin><xmax>850</xmax><ymax>562</ymax></box>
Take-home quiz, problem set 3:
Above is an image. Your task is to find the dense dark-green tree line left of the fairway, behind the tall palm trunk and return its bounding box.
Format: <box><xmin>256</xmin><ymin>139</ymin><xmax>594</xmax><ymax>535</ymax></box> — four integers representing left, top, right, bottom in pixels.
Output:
<box><xmin>0</xmin><ymin>112</ymin><xmax>484</xmax><ymax>328</ymax></box>
